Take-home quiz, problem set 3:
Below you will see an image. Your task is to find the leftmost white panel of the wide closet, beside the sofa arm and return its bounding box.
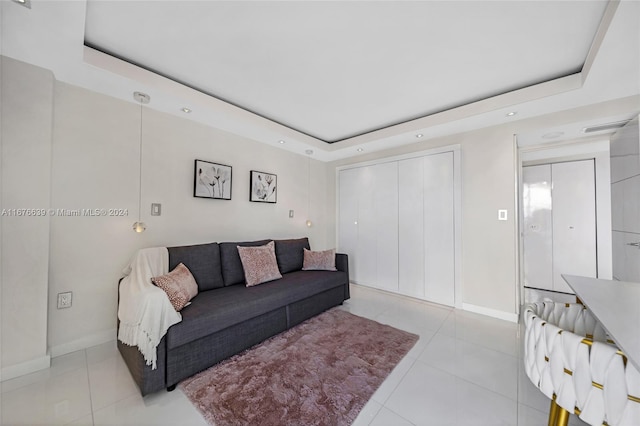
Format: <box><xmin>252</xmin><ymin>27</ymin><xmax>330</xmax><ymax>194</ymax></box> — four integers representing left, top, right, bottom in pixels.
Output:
<box><xmin>338</xmin><ymin>169</ymin><xmax>360</xmax><ymax>281</ymax></box>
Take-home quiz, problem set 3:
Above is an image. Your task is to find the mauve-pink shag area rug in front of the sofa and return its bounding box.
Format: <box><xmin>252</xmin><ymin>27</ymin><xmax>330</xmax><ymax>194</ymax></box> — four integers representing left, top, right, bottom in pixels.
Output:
<box><xmin>180</xmin><ymin>308</ymin><xmax>418</xmax><ymax>426</ymax></box>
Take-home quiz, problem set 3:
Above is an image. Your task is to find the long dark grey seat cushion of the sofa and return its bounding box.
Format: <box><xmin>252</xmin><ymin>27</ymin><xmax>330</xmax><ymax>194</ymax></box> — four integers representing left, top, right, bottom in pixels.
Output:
<box><xmin>167</xmin><ymin>271</ymin><xmax>348</xmax><ymax>349</ymax></box>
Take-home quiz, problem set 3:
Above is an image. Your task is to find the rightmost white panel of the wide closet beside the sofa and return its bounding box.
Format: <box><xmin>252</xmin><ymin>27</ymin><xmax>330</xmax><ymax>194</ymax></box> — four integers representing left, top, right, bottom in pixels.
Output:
<box><xmin>423</xmin><ymin>152</ymin><xmax>455</xmax><ymax>306</ymax></box>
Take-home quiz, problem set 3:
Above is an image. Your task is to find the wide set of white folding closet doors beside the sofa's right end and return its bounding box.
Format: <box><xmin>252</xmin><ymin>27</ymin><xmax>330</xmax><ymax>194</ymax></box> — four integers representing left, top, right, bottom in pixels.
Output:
<box><xmin>338</xmin><ymin>152</ymin><xmax>455</xmax><ymax>306</ymax></box>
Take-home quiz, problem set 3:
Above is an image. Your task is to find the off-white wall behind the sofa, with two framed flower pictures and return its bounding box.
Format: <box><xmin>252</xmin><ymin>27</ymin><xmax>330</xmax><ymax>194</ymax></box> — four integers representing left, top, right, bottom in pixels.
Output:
<box><xmin>48</xmin><ymin>82</ymin><xmax>334</xmax><ymax>356</ymax></box>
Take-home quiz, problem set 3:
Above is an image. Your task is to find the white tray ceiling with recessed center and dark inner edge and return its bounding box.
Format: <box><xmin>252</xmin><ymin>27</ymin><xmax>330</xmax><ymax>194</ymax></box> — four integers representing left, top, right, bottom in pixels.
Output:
<box><xmin>2</xmin><ymin>0</ymin><xmax>640</xmax><ymax>161</ymax></box>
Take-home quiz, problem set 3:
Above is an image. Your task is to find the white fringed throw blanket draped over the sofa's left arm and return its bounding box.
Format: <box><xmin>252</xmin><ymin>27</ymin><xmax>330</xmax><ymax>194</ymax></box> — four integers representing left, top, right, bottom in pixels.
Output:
<box><xmin>118</xmin><ymin>247</ymin><xmax>182</xmax><ymax>370</ymax></box>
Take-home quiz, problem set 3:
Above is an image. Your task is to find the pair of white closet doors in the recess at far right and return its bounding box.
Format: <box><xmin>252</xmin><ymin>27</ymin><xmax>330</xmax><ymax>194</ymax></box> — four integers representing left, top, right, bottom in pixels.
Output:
<box><xmin>523</xmin><ymin>160</ymin><xmax>597</xmax><ymax>293</ymax></box>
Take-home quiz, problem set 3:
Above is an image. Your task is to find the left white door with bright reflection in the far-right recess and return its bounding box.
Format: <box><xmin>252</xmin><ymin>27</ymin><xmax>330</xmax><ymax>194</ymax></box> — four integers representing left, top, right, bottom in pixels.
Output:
<box><xmin>522</xmin><ymin>164</ymin><xmax>553</xmax><ymax>290</ymax></box>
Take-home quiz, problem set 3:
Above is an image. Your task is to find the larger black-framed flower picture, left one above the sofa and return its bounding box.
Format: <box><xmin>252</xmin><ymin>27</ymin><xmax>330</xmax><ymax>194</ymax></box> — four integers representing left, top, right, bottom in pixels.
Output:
<box><xmin>193</xmin><ymin>160</ymin><xmax>233</xmax><ymax>200</ymax></box>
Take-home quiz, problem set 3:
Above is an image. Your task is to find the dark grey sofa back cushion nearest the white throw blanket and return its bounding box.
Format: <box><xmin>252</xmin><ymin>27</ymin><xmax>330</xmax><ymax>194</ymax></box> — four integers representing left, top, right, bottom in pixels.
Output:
<box><xmin>167</xmin><ymin>243</ymin><xmax>224</xmax><ymax>291</ymax></box>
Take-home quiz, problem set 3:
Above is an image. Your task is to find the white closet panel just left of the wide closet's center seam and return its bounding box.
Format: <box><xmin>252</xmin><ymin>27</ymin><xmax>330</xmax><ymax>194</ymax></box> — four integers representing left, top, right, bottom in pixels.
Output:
<box><xmin>373</xmin><ymin>161</ymin><xmax>398</xmax><ymax>292</ymax></box>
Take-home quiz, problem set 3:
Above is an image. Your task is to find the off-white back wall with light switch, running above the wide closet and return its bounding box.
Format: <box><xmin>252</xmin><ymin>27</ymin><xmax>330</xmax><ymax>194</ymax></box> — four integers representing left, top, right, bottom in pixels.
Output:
<box><xmin>328</xmin><ymin>96</ymin><xmax>639</xmax><ymax>320</ymax></box>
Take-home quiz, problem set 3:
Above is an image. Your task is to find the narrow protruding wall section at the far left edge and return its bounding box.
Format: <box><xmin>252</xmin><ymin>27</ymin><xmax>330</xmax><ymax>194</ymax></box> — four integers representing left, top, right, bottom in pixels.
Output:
<box><xmin>0</xmin><ymin>57</ymin><xmax>54</xmax><ymax>379</ymax></box>
